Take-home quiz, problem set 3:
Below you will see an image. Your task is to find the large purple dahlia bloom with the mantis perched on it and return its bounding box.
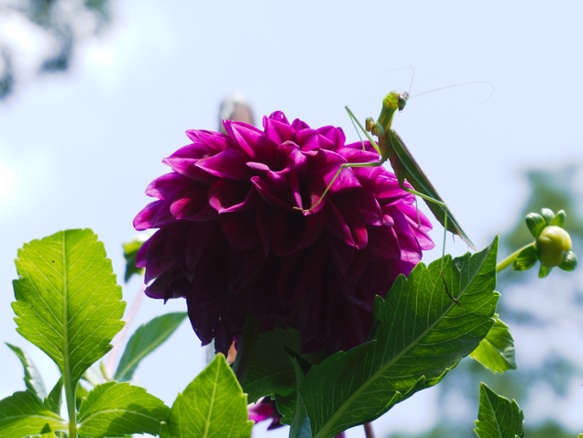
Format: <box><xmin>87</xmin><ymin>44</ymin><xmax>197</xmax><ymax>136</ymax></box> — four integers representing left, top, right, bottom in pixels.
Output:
<box><xmin>134</xmin><ymin>112</ymin><xmax>433</xmax><ymax>353</ymax></box>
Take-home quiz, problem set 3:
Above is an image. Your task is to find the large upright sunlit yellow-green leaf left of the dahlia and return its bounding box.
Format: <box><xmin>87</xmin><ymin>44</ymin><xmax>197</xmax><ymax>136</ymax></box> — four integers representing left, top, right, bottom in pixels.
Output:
<box><xmin>12</xmin><ymin>229</ymin><xmax>125</xmax><ymax>384</ymax></box>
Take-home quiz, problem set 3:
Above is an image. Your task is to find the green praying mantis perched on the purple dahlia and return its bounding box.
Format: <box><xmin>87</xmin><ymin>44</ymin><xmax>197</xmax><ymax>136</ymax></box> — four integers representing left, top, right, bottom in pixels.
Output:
<box><xmin>303</xmin><ymin>91</ymin><xmax>475</xmax><ymax>249</ymax></box>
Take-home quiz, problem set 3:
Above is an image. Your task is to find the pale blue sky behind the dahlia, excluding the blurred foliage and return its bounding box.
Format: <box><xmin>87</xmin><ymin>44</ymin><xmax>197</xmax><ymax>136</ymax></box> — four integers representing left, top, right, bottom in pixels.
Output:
<box><xmin>0</xmin><ymin>0</ymin><xmax>583</xmax><ymax>437</ymax></box>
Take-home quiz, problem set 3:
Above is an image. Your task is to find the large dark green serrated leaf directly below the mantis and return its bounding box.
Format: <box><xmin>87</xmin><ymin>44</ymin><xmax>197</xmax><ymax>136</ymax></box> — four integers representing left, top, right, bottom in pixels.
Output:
<box><xmin>300</xmin><ymin>240</ymin><xmax>499</xmax><ymax>437</ymax></box>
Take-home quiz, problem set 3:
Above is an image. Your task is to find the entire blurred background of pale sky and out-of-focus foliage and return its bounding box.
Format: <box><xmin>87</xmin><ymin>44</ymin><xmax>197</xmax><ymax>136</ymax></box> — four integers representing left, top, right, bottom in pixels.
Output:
<box><xmin>0</xmin><ymin>0</ymin><xmax>583</xmax><ymax>437</ymax></box>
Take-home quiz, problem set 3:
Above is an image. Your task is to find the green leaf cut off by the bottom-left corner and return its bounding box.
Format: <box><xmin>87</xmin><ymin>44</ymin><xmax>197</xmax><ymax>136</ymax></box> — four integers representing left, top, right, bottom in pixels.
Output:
<box><xmin>0</xmin><ymin>391</ymin><xmax>68</xmax><ymax>438</ymax></box>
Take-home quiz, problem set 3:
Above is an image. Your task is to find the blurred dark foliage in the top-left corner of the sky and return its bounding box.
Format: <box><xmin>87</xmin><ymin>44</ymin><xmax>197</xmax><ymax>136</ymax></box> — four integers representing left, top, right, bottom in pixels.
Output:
<box><xmin>0</xmin><ymin>0</ymin><xmax>111</xmax><ymax>99</ymax></box>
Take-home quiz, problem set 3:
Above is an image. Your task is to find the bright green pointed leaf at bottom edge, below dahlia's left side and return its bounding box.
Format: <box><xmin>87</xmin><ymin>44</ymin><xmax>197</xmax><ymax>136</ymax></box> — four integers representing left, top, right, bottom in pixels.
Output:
<box><xmin>160</xmin><ymin>354</ymin><xmax>253</xmax><ymax>438</ymax></box>
